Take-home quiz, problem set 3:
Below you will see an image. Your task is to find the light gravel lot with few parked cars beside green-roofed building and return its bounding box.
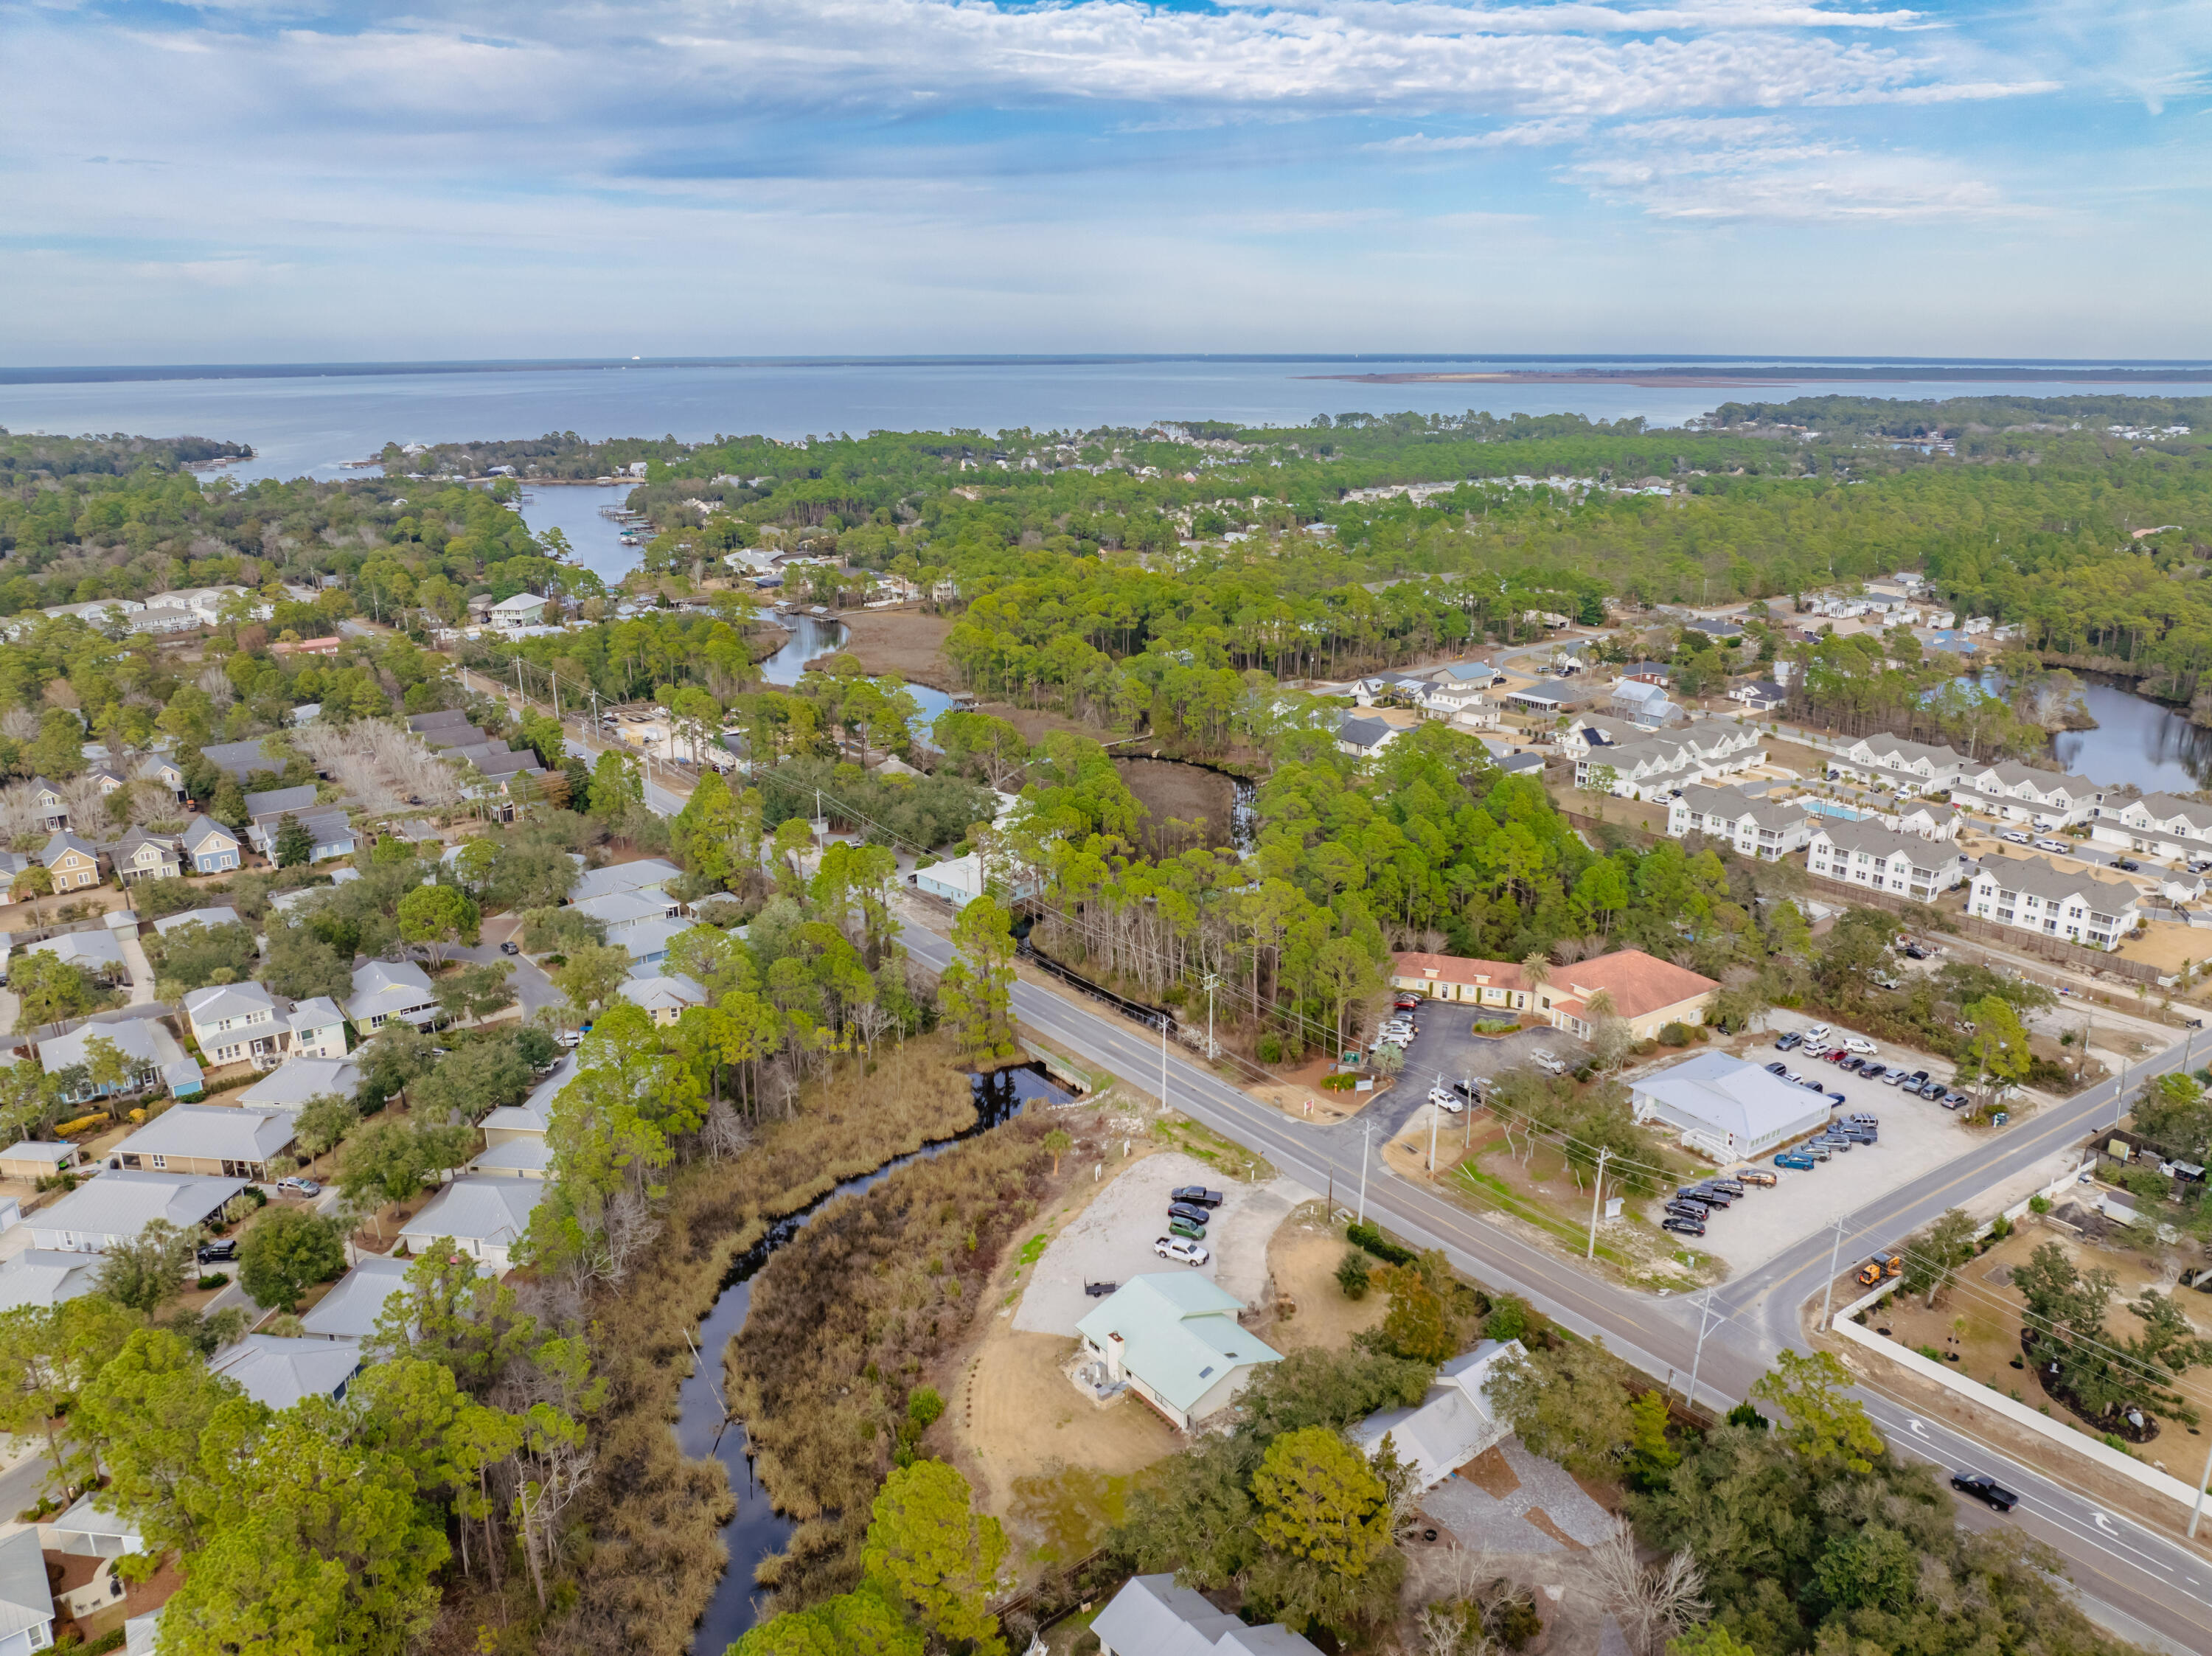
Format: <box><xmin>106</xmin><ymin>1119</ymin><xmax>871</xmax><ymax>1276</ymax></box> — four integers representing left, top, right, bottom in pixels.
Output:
<box><xmin>1013</xmin><ymin>1152</ymin><xmax>1314</xmax><ymax>1333</ymax></box>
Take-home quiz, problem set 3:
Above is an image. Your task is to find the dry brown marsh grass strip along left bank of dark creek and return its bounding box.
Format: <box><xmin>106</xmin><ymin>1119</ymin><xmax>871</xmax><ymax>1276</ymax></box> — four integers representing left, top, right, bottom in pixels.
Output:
<box><xmin>538</xmin><ymin>1039</ymin><xmax>975</xmax><ymax>1656</ymax></box>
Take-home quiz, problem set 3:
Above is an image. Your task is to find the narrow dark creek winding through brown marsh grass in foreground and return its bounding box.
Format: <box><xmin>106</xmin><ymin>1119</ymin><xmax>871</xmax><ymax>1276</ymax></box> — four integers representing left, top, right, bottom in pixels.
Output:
<box><xmin>675</xmin><ymin>1063</ymin><xmax>1068</xmax><ymax>1656</ymax></box>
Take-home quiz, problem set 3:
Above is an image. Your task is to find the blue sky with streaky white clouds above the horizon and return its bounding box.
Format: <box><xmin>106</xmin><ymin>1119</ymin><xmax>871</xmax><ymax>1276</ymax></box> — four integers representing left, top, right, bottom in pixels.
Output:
<box><xmin>0</xmin><ymin>0</ymin><xmax>2212</xmax><ymax>365</ymax></box>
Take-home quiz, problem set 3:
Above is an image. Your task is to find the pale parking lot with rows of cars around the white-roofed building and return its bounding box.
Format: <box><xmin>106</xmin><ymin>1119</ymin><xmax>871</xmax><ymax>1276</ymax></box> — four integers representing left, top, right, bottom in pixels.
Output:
<box><xmin>1679</xmin><ymin>1008</ymin><xmax>1989</xmax><ymax>1271</ymax></box>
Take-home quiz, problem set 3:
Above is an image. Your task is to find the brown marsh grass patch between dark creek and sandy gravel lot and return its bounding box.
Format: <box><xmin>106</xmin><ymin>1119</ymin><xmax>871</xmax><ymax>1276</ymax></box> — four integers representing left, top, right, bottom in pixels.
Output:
<box><xmin>728</xmin><ymin>1116</ymin><xmax>1053</xmax><ymax>1610</ymax></box>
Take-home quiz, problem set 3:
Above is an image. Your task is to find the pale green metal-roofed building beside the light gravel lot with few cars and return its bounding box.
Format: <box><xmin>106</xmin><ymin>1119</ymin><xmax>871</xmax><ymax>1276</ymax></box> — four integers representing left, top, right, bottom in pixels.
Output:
<box><xmin>1075</xmin><ymin>1271</ymin><xmax>1283</xmax><ymax>1430</ymax></box>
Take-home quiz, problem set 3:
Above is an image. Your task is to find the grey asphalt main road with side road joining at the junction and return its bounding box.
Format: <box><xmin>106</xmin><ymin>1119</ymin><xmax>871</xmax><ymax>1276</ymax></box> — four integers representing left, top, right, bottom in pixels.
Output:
<box><xmin>905</xmin><ymin>926</ymin><xmax>2212</xmax><ymax>1652</ymax></box>
